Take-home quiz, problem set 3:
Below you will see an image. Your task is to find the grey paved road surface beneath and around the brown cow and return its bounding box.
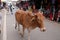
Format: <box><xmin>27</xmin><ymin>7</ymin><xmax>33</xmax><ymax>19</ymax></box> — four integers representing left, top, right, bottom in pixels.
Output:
<box><xmin>6</xmin><ymin>8</ymin><xmax>60</xmax><ymax>40</ymax></box>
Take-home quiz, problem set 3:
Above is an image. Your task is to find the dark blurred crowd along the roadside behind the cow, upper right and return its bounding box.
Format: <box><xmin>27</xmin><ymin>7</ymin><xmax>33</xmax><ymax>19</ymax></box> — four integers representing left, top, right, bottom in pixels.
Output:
<box><xmin>16</xmin><ymin>0</ymin><xmax>60</xmax><ymax>22</ymax></box>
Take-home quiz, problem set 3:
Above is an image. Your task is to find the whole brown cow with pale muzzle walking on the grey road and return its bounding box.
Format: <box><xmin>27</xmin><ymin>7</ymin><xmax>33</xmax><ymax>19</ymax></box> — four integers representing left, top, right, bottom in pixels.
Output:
<box><xmin>15</xmin><ymin>10</ymin><xmax>46</xmax><ymax>40</ymax></box>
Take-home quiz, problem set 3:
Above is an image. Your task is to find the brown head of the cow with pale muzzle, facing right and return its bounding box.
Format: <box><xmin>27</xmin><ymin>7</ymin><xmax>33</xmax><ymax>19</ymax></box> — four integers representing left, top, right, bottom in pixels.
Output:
<box><xmin>31</xmin><ymin>15</ymin><xmax>46</xmax><ymax>32</ymax></box>
